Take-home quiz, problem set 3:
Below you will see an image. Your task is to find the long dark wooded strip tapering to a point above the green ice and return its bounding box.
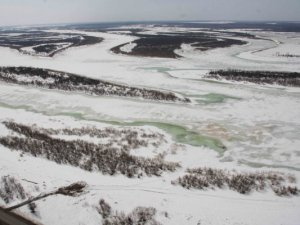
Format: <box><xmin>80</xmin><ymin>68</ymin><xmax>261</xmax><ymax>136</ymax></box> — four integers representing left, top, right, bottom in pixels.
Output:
<box><xmin>0</xmin><ymin>67</ymin><xmax>190</xmax><ymax>103</ymax></box>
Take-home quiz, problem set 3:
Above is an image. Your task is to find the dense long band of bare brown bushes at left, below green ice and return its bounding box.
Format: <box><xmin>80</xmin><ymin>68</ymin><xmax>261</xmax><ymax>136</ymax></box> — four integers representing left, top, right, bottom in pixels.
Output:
<box><xmin>0</xmin><ymin>122</ymin><xmax>180</xmax><ymax>177</ymax></box>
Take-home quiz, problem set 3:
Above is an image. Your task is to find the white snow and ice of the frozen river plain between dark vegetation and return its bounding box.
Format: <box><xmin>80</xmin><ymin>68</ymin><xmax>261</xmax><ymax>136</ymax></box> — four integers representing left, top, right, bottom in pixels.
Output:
<box><xmin>0</xmin><ymin>27</ymin><xmax>300</xmax><ymax>225</ymax></box>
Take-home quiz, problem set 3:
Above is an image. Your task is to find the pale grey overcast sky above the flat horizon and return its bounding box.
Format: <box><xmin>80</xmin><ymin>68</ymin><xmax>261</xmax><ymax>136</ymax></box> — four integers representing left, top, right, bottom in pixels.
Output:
<box><xmin>0</xmin><ymin>0</ymin><xmax>300</xmax><ymax>25</ymax></box>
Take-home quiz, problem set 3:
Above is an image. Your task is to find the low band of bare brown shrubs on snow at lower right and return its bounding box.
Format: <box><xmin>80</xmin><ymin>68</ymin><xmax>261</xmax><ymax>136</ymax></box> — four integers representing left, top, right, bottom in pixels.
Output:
<box><xmin>172</xmin><ymin>168</ymin><xmax>299</xmax><ymax>196</ymax></box>
